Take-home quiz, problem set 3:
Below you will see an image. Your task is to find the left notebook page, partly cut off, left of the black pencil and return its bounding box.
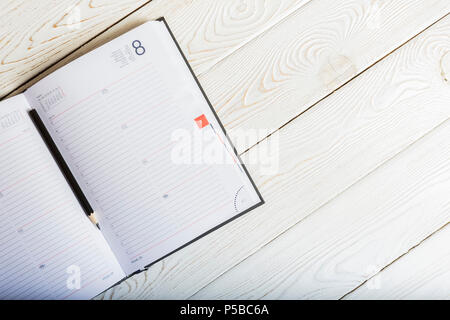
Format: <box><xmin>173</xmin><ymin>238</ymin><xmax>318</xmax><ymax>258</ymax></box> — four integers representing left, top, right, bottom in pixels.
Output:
<box><xmin>0</xmin><ymin>95</ymin><xmax>125</xmax><ymax>299</ymax></box>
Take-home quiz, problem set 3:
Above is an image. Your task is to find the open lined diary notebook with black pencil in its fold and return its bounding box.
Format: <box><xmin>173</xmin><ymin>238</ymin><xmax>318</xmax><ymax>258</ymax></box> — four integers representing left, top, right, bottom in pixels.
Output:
<box><xmin>0</xmin><ymin>18</ymin><xmax>263</xmax><ymax>299</ymax></box>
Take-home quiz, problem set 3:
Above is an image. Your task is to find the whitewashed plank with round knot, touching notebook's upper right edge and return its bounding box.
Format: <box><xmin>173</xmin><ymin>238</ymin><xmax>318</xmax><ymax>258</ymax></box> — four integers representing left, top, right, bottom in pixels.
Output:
<box><xmin>201</xmin><ymin>0</ymin><xmax>450</xmax><ymax>150</ymax></box>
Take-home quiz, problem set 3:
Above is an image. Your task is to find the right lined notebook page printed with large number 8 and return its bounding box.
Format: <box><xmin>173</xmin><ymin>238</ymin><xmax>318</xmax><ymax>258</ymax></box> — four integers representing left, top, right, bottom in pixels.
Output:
<box><xmin>26</xmin><ymin>22</ymin><xmax>261</xmax><ymax>274</ymax></box>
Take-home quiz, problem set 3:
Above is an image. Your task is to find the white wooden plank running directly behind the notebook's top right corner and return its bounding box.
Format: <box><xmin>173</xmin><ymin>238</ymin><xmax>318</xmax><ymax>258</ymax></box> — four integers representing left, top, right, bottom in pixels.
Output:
<box><xmin>4</xmin><ymin>0</ymin><xmax>310</xmax><ymax>98</ymax></box>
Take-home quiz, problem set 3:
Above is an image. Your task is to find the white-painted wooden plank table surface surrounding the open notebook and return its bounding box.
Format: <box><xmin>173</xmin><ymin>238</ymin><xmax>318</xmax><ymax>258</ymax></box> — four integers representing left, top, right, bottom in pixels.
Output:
<box><xmin>0</xmin><ymin>0</ymin><xmax>450</xmax><ymax>299</ymax></box>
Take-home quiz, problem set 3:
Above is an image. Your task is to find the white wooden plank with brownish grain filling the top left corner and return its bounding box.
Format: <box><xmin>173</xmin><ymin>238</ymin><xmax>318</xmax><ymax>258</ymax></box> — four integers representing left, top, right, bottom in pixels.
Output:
<box><xmin>0</xmin><ymin>0</ymin><xmax>148</xmax><ymax>98</ymax></box>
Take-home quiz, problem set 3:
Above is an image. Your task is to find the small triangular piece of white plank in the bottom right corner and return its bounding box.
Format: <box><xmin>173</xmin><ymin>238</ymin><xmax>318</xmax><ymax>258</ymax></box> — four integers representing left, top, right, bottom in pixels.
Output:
<box><xmin>345</xmin><ymin>225</ymin><xmax>450</xmax><ymax>300</ymax></box>
